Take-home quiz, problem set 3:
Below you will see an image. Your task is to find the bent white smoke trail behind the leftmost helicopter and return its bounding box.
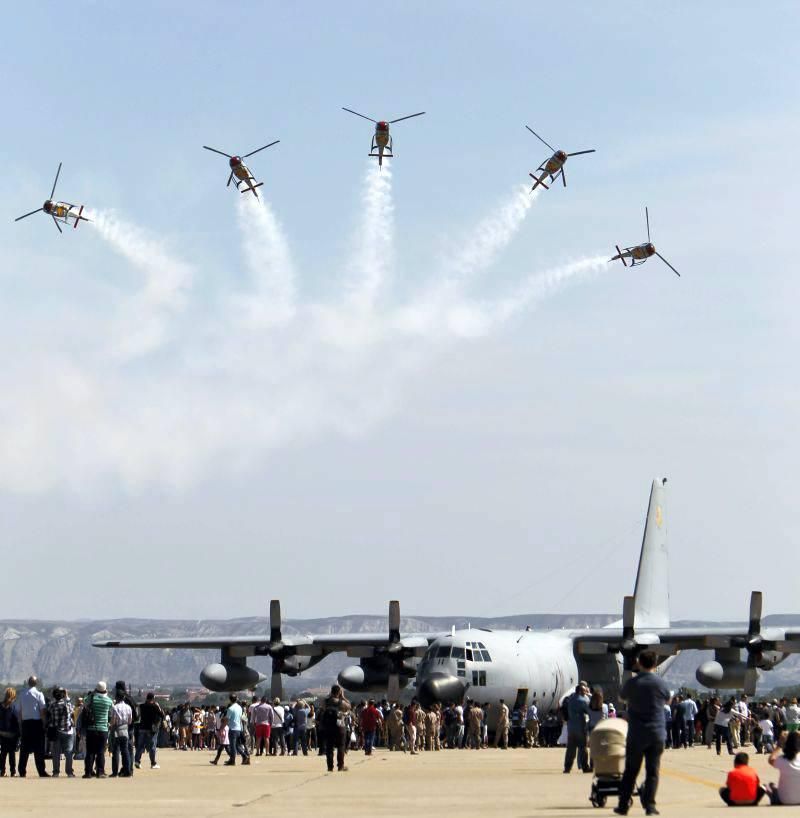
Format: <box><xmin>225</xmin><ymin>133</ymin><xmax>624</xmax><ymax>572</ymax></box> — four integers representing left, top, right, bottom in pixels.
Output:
<box><xmin>89</xmin><ymin>211</ymin><xmax>194</xmax><ymax>359</ymax></box>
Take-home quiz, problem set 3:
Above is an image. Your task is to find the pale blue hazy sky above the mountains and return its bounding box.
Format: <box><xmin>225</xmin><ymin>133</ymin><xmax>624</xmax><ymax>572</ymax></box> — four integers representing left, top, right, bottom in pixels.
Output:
<box><xmin>0</xmin><ymin>2</ymin><xmax>800</xmax><ymax>617</ymax></box>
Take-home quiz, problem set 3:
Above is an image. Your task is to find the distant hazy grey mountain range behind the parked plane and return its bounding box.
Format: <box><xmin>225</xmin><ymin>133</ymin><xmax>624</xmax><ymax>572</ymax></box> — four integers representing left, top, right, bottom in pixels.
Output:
<box><xmin>0</xmin><ymin>614</ymin><xmax>800</xmax><ymax>692</ymax></box>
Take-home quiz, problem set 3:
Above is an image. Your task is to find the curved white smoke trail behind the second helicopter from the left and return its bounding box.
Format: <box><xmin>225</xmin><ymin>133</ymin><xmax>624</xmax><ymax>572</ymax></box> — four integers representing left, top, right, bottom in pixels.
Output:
<box><xmin>236</xmin><ymin>195</ymin><xmax>296</xmax><ymax>327</ymax></box>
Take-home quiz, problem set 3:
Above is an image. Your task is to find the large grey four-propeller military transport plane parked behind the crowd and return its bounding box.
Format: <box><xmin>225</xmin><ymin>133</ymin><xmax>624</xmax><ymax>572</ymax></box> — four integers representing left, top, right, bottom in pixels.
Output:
<box><xmin>94</xmin><ymin>480</ymin><xmax>800</xmax><ymax>727</ymax></box>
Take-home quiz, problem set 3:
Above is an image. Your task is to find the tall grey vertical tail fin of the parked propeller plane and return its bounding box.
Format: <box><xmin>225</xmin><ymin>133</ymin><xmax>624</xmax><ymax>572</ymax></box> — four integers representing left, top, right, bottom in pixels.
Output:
<box><xmin>633</xmin><ymin>478</ymin><xmax>670</xmax><ymax>631</ymax></box>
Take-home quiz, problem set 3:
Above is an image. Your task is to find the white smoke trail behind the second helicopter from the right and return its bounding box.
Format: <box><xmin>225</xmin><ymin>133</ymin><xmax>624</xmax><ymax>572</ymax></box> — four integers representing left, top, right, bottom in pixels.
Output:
<box><xmin>445</xmin><ymin>185</ymin><xmax>541</xmax><ymax>279</ymax></box>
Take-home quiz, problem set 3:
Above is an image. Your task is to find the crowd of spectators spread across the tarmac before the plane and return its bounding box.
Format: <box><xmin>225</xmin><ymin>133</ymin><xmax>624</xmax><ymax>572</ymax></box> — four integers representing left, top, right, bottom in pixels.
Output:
<box><xmin>0</xmin><ymin>672</ymin><xmax>800</xmax><ymax>814</ymax></box>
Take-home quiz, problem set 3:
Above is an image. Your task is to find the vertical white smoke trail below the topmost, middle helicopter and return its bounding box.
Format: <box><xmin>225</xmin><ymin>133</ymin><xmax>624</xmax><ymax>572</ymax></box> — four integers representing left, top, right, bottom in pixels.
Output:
<box><xmin>349</xmin><ymin>161</ymin><xmax>394</xmax><ymax>310</ymax></box>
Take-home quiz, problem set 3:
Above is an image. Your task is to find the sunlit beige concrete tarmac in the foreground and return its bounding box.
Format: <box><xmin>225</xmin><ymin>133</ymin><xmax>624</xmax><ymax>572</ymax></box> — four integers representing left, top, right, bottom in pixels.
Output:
<box><xmin>0</xmin><ymin>747</ymin><xmax>777</xmax><ymax>818</ymax></box>
